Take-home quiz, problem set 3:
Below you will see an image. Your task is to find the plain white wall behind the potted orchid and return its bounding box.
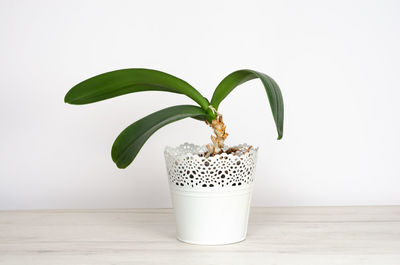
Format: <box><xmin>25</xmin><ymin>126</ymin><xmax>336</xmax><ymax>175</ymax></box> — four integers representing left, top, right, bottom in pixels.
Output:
<box><xmin>0</xmin><ymin>0</ymin><xmax>400</xmax><ymax>209</ymax></box>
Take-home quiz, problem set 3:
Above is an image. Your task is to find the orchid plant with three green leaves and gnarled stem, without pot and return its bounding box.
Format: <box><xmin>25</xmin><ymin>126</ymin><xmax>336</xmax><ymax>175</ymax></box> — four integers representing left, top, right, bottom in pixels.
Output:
<box><xmin>64</xmin><ymin>68</ymin><xmax>284</xmax><ymax>168</ymax></box>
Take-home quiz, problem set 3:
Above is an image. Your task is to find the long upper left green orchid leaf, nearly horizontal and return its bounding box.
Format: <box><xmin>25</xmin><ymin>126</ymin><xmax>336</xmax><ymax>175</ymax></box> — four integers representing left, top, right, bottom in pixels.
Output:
<box><xmin>64</xmin><ymin>68</ymin><xmax>210</xmax><ymax>110</ymax></box>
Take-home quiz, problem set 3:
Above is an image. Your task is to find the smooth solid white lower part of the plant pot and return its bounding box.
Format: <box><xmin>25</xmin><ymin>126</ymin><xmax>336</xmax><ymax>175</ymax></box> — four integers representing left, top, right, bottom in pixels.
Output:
<box><xmin>171</xmin><ymin>186</ymin><xmax>252</xmax><ymax>245</ymax></box>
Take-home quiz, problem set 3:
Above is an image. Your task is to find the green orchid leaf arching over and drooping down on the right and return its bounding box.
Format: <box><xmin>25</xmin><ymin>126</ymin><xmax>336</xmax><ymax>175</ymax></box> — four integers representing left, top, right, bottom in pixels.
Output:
<box><xmin>211</xmin><ymin>70</ymin><xmax>284</xmax><ymax>140</ymax></box>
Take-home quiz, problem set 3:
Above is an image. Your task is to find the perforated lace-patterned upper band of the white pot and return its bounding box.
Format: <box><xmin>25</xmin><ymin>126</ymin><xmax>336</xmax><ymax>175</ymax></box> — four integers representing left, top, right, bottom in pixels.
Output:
<box><xmin>164</xmin><ymin>143</ymin><xmax>258</xmax><ymax>190</ymax></box>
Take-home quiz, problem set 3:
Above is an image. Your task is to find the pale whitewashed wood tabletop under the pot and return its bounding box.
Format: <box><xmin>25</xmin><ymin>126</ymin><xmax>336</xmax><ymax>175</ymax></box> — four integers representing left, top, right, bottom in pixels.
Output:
<box><xmin>0</xmin><ymin>206</ymin><xmax>400</xmax><ymax>265</ymax></box>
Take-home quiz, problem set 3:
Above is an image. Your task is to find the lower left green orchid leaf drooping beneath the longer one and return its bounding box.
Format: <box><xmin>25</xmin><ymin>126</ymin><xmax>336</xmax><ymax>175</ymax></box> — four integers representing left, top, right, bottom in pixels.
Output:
<box><xmin>111</xmin><ymin>105</ymin><xmax>207</xmax><ymax>168</ymax></box>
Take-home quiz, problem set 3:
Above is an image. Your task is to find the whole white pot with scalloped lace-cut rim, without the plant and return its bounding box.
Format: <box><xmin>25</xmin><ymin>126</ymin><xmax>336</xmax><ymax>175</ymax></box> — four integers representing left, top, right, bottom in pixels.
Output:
<box><xmin>164</xmin><ymin>143</ymin><xmax>258</xmax><ymax>245</ymax></box>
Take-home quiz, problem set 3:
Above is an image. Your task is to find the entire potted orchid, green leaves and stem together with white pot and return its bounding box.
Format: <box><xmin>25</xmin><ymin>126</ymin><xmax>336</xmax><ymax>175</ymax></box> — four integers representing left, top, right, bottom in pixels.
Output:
<box><xmin>64</xmin><ymin>68</ymin><xmax>283</xmax><ymax>245</ymax></box>
